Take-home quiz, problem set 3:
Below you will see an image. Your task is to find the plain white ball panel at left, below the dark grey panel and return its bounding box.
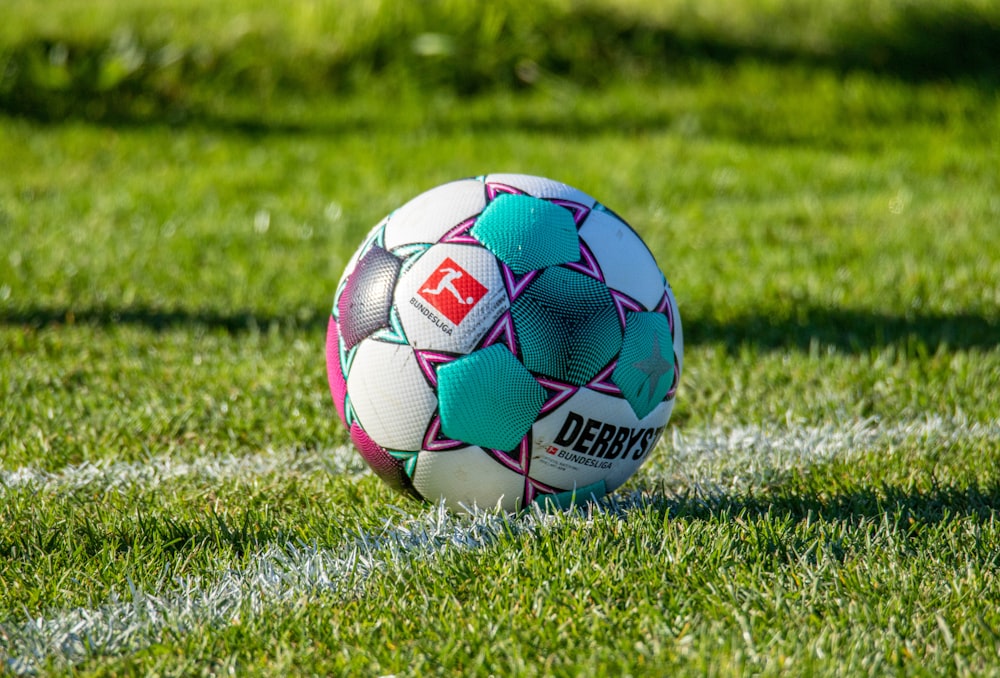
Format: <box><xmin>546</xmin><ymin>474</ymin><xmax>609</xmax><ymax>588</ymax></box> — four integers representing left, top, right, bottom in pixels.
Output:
<box><xmin>347</xmin><ymin>339</ymin><xmax>437</xmax><ymax>451</ymax></box>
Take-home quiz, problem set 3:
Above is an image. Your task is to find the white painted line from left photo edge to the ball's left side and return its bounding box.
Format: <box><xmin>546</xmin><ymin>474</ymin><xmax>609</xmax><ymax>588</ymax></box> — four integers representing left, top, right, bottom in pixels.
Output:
<box><xmin>0</xmin><ymin>446</ymin><xmax>367</xmax><ymax>498</ymax></box>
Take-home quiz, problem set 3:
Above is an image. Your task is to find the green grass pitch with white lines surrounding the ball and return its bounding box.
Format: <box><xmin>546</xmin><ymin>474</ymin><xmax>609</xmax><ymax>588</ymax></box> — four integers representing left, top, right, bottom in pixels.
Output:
<box><xmin>0</xmin><ymin>0</ymin><xmax>1000</xmax><ymax>675</ymax></box>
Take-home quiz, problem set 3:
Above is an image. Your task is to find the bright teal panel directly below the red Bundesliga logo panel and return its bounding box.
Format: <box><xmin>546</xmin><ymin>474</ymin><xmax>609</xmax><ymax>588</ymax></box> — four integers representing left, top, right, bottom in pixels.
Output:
<box><xmin>437</xmin><ymin>344</ymin><xmax>546</xmax><ymax>450</ymax></box>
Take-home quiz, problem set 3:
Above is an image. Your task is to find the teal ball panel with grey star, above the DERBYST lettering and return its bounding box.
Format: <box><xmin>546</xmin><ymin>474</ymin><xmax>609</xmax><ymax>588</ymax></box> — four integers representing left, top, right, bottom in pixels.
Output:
<box><xmin>611</xmin><ymin>312</ymin><xmax>674</xmax><ymax>418</ymax></box>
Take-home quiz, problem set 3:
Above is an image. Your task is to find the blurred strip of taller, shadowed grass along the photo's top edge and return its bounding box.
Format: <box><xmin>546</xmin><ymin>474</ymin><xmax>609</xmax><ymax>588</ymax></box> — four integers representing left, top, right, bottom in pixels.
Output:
<box><xmin>0</xmin><ymin>0</ymin><xmax>1000</xmax><ymax>121</ymax></box>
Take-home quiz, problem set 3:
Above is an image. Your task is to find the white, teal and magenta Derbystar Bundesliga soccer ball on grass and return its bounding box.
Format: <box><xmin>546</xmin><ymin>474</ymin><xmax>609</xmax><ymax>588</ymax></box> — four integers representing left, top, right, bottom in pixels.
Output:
<box><xmin>326</xmin><ymin>174</ymin><xmax>684</xmax><ymax>511</ymax></box>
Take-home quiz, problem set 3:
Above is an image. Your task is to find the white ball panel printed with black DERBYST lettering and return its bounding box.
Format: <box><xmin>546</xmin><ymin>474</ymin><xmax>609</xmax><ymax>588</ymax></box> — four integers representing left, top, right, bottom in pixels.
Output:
<box><xmin>529</xmin><ymin>388</ymin><xmax>674</xmax><ymax>492</ymax></box>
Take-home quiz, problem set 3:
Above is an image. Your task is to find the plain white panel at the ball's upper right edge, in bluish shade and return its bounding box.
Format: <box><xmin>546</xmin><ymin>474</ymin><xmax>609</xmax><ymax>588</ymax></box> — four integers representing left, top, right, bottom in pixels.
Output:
<box><xmin>580</xmin><ymin>211</ymin><xmax>663</xmax><ymax>310</ymax></box>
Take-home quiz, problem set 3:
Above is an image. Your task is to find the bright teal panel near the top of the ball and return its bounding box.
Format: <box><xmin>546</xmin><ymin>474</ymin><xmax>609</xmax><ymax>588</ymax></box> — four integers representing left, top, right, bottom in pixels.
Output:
<box><xmin>469</xmin><ymin>193</ymin><xmax>580</xmax><ymax>275</ymax></box>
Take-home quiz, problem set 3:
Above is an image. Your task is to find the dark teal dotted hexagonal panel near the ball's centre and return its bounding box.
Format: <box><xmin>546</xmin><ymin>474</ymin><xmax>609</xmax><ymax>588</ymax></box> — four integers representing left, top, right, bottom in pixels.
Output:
<box><xmin>511</xmin><ymin>266</ymin><xmax>622</xmax><ymax>386</ymax></box>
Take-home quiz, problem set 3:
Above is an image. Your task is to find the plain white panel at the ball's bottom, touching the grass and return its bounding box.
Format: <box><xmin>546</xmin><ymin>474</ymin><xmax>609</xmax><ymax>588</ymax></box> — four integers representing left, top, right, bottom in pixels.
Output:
<box><xmin>413</xmin><ymin>447</ymin><xmax>524</xmax><ymax>511</ymax></box>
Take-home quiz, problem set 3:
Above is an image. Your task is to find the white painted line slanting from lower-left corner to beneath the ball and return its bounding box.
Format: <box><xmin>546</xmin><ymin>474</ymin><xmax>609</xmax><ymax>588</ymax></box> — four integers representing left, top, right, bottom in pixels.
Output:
<box><xmin>0</xmin><ymin>505</ymin><xmax>557</xmax><ymax>674</ymax></box>
